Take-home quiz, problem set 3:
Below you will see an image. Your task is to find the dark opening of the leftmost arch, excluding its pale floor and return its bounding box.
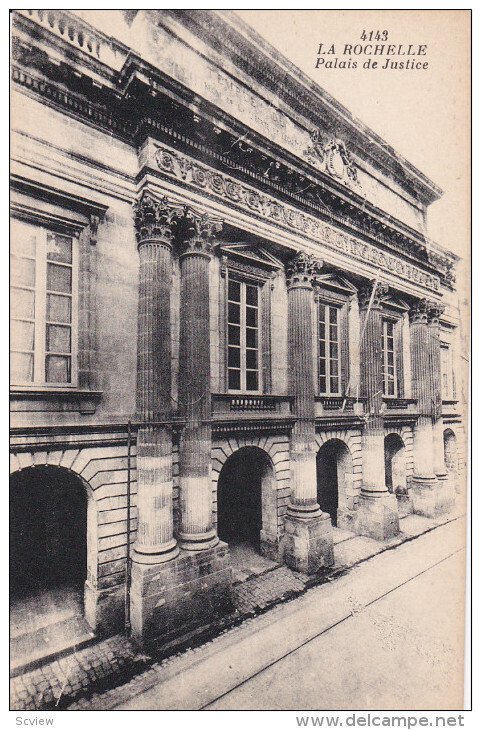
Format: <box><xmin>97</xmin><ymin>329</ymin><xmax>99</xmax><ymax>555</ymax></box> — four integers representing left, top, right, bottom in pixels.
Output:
<box><xmin>10</xmin><ymin>466</ymin><xmax>87</xmax><ymax>598</ymax></box>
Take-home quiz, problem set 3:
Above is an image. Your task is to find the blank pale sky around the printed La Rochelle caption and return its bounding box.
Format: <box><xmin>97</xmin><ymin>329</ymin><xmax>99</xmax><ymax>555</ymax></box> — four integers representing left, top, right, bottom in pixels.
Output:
<box><xmin>236</xmin><ymin>10</ymin><xmax>470</xmax><ymax>257</ymax></box>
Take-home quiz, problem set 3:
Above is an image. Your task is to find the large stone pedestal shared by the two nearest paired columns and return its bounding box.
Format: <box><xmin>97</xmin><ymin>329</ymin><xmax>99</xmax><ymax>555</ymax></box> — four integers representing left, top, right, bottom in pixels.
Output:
<box><xmin>130</xmin><ymin>542</ymin><xmax>233</xmax><ymax>648</ymax></box>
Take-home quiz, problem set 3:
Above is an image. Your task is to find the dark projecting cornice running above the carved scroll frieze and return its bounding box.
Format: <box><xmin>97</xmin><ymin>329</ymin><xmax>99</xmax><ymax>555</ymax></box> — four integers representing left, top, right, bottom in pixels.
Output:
<box><xmin>12</xmin><ymin>14</ymin><xmax>454</xmax><ymax>287</ymax></box>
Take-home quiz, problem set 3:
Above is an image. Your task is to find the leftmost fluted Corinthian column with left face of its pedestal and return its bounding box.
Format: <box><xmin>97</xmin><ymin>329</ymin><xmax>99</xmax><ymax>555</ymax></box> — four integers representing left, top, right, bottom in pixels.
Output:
<box><xmin>130</xmin><ymin>192</ymin><xmax>179</xmax><ymax>643</ymax></box>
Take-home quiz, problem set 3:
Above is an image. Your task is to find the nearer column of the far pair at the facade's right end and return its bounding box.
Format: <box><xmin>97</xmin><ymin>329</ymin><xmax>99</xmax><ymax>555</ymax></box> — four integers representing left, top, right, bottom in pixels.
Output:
<box><xmin>409</xmin><ymin>299</ymin><xmax>437</xmax><ymax>517</ymax></box>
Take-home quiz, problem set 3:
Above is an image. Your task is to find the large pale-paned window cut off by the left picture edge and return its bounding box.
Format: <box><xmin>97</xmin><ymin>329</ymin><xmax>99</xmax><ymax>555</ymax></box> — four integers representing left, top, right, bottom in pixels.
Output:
<box><xmin>10</xmin><ymin>220</ymin><xmax>77</xmax><ymax>385</ymax></box>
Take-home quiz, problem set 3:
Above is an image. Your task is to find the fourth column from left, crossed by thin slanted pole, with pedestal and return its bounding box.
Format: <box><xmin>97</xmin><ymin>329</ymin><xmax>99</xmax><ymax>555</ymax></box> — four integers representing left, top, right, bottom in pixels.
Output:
<box><xmin>356</xmin><ymin>282</ymin><xmax>399</xmax><ymax>540</ymax></box>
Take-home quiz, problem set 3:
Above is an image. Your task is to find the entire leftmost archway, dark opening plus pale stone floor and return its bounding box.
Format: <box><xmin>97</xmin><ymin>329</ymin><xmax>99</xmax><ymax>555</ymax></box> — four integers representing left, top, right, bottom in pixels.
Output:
<box><xmin>10</xmin><ymin>466</ymin><xmax>87</xmax><ymax>665</ymax></box>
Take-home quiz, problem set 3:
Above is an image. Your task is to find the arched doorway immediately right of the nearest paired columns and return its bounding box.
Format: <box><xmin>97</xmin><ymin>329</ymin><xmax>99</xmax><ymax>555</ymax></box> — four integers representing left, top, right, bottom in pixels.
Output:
<box><xmin>217</xmin><ymin>446</ymin><xmax>277</xmax><ymax>551</ymax></box>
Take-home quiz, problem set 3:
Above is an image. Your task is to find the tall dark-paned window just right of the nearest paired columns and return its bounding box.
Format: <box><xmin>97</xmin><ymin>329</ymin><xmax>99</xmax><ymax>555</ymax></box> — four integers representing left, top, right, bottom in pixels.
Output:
<box><xmin>227</xmin><ymin>277</ymin><xmax>261</xmax><ymax>393</ymax></box>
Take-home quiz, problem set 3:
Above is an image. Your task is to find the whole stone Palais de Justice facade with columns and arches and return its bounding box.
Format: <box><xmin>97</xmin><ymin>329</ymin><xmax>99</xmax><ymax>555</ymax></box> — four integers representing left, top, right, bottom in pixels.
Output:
<box><xmin>11</xmin><ymin>10</ymin><xmax>465</xmax><ymax>644</ymax></box>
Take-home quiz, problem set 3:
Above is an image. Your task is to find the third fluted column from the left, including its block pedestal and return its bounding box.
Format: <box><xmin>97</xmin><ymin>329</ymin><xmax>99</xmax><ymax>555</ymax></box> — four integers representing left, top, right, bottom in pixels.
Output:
<box><xmin>283</xmin><ymin>252</ymin><xmax>334</xmax><ymax>574</ymax></box>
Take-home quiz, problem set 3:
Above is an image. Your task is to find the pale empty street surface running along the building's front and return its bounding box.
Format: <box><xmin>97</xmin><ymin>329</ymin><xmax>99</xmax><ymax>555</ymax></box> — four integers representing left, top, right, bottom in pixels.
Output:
<box><xmin>115</xmin><ymin>519</ymin><xmax>465</xmax><ymax>710</ymax></box>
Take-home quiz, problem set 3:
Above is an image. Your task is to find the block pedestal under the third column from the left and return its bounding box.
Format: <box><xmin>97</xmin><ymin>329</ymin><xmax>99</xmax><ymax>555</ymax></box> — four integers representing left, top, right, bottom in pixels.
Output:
<box><xmin>280</xmin><ymin>512</ymin><xmax>334</xmax><ymax>575</ymax></box>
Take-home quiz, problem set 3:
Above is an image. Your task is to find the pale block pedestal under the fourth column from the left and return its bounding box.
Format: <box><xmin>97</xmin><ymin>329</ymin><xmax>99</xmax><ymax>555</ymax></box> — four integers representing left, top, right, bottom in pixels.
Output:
<box><xmin>355</xmin><ymin>492</ymin><xmax>399</xmax><ymax>540</ymax></box>
